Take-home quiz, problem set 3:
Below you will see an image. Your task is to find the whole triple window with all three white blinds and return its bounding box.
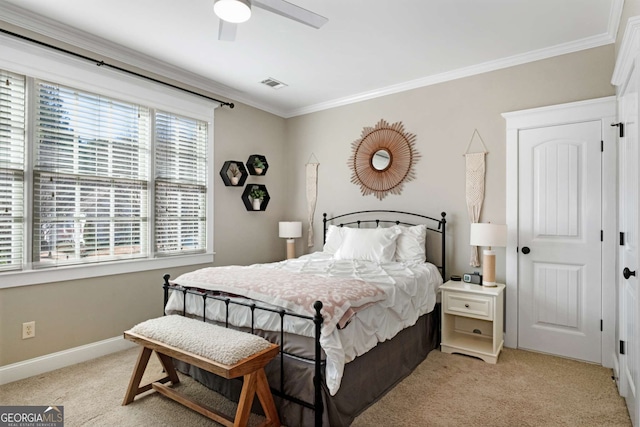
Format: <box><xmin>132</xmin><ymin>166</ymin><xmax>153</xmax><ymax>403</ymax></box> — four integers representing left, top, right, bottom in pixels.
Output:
<box><xmin>0</xmin><ymin>41</ymin><xmax>213</xmax><ymax>287</ymax></box>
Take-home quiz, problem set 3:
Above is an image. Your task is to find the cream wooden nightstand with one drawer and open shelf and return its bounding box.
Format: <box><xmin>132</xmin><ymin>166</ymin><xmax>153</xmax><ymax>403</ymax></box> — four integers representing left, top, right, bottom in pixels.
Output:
<box><xmin>440</xmin><ymin>281</ymin><xmax>505</xmax><ymax>363</ymax></box>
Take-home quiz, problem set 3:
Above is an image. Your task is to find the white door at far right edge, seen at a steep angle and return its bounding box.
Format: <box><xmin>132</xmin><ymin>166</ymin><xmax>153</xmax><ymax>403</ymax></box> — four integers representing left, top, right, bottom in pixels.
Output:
<box><xmin>618</xmin><ymin>71</ymin><xmax>640</xmax><ymax>426</ymax></box>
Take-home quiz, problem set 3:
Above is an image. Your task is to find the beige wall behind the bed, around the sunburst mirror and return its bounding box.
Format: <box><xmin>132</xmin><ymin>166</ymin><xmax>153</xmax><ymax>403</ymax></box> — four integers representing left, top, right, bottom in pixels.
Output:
<box><xmin>287</xmin><ymin>45</ymin><xmax>615</xmax><ymax>280</ymax></box>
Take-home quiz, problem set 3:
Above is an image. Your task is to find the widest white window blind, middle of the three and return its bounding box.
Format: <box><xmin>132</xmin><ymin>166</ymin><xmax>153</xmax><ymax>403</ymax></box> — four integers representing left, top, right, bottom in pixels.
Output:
<box><xmin>33</xmin><ymin>82</ymin><xmax>150</xmax><ymax>267</ymax></box>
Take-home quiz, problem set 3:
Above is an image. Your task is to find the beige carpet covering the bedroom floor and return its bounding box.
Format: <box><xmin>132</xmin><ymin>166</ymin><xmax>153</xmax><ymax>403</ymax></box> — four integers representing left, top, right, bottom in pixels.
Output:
<box><xmin>0</xmin><ymin>349</ymin><xmax>631</xmax><ymax>427</ymax></box>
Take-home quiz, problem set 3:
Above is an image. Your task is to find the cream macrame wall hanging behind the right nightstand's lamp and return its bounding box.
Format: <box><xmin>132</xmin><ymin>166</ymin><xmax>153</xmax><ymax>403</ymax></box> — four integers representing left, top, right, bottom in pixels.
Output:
<box><xmin>464</xmin><ymin>129</ymin><xmax>489</xmax><ymax>267</ymax></box>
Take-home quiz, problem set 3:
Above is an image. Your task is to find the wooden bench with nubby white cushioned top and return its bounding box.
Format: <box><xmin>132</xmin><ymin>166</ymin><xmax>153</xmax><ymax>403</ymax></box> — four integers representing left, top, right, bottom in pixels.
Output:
<box><xmin>122</xmin><ymin>315</ymin><xmax>280</xmax><ymax>427</ymax></box>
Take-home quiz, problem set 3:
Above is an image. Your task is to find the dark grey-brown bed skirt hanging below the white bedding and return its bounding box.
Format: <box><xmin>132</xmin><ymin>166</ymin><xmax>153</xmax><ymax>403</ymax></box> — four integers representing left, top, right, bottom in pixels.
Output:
<box><xmin>174</xmin><ymin>304</ymin><xmax>440</xmax><ymax>427</ymax></box>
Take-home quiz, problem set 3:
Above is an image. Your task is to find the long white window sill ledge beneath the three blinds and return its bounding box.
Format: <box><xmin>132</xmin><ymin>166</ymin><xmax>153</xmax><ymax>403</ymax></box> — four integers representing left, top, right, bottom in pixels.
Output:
<box><xmin>0</xmin><ymin>253</ymin><xmax>214</xmax><ymax>289</ymax></box>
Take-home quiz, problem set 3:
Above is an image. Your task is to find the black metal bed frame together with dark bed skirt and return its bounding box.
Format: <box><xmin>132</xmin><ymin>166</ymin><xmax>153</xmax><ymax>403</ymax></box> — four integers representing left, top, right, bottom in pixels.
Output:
<box><xmin>163</xmin><ymin>210</ymin><xmax>446</xmax><ymax>426</ymax></box>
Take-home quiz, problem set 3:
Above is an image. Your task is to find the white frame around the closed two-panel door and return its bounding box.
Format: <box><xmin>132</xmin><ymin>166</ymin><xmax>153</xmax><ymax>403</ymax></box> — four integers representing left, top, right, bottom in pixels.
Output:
<box><xmin>502</xmin><ymin>96</ymin><xmax>618</xmax><ymax>368</ymax></box>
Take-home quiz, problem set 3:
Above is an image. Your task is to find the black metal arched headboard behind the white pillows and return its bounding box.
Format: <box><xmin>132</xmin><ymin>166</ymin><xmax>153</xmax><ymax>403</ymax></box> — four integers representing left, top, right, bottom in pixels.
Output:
<box><xmin>322</xmin><ymin>209</ymin><xmax>447</xmax><ymax>280</ymax></box>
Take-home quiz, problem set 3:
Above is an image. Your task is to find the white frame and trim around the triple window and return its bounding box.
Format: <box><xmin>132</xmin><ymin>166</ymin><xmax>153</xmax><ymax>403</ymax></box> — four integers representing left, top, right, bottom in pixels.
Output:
<box><xmin>0</xmin><ymin>35</ymin><xmax>218</xmax><ymax>289</ymax></box>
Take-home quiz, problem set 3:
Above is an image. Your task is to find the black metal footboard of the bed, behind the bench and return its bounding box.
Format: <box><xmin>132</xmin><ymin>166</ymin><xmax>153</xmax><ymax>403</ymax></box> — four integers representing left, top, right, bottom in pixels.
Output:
<box><xmin>162</xmin><ymin>274</ymin><xmax>325</xmax><ymax>426</ymax></box>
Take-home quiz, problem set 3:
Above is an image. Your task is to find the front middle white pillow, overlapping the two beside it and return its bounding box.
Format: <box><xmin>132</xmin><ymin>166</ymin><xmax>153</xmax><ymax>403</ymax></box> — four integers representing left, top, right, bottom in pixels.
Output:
<box><xmin>333</xmin><ymin>227</ymin><xmax>400</xmax><ymax>263</ymax></box>
